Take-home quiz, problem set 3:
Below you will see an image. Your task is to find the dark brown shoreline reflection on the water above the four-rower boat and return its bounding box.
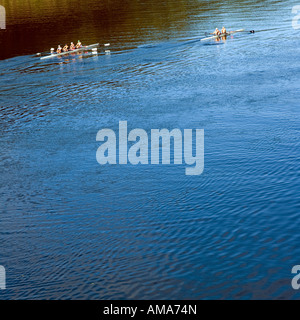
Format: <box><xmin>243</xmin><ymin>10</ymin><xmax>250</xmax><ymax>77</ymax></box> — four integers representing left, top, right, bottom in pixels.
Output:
<box><xmin>1</xmin><ymin>0</ymin><xmax>211</xmax><ymax>58</ymax></box>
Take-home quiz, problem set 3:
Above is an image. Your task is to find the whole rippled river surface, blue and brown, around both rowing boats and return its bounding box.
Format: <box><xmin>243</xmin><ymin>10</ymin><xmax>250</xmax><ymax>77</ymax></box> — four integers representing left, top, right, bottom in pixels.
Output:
<box><xmin>0</xmin><ymin>0</ymin><xmax>300</xmax><ymax>299</ymax></box>
